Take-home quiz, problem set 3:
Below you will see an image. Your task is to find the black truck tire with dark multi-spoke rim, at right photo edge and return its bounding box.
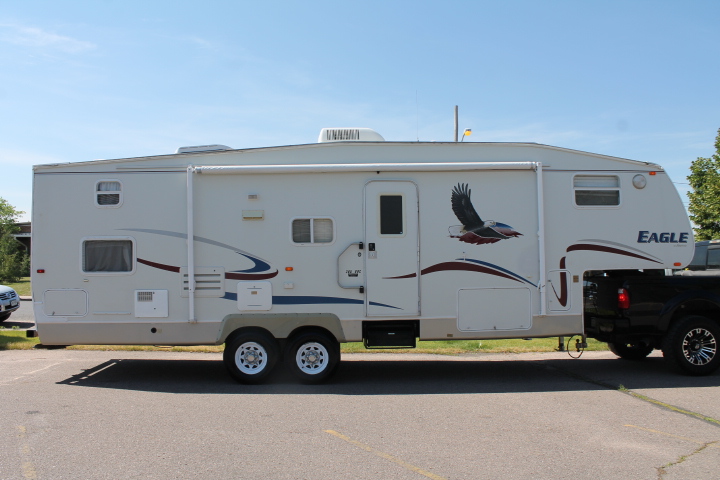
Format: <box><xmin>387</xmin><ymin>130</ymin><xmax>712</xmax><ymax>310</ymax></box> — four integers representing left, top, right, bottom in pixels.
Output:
<box><xmin>662</xmin><ymin>315</ymin><xmax>720</xmax><ymax>375</ymax></box>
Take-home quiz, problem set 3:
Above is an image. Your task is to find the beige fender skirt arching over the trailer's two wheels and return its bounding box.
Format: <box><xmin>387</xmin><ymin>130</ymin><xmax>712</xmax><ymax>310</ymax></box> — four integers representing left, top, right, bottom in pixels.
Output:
<box><xmin>217</xmin><ymin>313</ymin><xmax>345</xmax><ymax>345</ymax></box>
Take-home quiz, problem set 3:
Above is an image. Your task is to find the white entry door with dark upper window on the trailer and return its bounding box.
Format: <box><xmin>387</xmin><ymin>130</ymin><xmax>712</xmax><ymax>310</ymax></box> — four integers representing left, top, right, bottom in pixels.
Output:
<box><xmin>365</xmin><ymin>181</ymin><xmax>420</xmax><ymax>316</ymax></box>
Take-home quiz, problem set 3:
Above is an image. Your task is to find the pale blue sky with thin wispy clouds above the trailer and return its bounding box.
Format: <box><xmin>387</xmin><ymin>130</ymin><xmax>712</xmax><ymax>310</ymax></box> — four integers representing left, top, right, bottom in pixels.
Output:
<box><xmin>0</xmin><ymin>0</ymin><xmax>720</xmax><ymax>219</ymax></box>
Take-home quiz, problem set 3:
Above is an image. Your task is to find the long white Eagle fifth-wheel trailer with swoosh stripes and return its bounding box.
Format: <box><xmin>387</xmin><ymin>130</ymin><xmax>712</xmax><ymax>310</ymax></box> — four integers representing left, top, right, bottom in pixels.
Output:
<box><xmin>32</xmin><ymin>129</ymin><xmax>694</xmax><ymax>383</ymax></box>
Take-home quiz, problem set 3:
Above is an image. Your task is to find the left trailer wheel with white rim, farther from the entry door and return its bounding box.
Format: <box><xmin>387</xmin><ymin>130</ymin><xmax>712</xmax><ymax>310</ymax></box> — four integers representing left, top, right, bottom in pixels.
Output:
<box><xmin>223</xmin><ymin>330</ymin><xmax>280</xmax><ymax>384</ymax></box>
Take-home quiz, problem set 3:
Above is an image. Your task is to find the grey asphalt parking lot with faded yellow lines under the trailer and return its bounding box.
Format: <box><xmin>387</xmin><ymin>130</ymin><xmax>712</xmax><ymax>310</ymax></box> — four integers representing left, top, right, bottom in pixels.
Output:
<box><xmin>0</xmin><ymin>350</ymin><xmax>720</xmax><ymax>480</ymax></box>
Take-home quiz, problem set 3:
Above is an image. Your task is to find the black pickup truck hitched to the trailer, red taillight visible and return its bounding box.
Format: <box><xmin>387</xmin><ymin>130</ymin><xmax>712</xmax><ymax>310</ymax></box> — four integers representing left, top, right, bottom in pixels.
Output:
<box><xmin>583</xmin><ymin>241</ymin><xmax>720</xmax><ymax>375</ymax></box>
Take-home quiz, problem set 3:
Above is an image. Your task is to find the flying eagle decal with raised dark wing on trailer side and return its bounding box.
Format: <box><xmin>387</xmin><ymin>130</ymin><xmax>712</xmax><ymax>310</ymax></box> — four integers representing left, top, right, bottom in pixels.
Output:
<box><xmin>448</xmin><ymin>183</ymin><xmax>522</xmax><ymax>245</ymax></box>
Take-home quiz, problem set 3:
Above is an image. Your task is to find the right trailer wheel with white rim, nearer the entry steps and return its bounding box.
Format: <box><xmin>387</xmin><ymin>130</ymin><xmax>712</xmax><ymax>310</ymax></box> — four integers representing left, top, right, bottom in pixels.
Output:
<box><xmin>285</xmin><ymin>331</ymin><xmax>340</xmax><ymax>384</ymax></box>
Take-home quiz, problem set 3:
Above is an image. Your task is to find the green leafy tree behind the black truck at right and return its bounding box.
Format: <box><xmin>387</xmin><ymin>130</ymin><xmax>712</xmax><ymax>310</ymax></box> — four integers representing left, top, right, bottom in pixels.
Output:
<box><xmin>688</xmin><ymin>129</ymin><xmax>720</xmax><ymax>240</ymax></box>
